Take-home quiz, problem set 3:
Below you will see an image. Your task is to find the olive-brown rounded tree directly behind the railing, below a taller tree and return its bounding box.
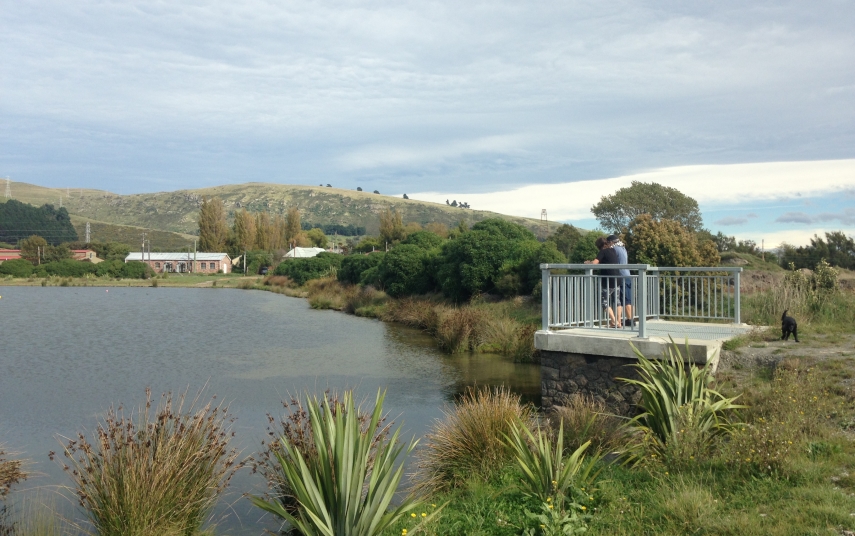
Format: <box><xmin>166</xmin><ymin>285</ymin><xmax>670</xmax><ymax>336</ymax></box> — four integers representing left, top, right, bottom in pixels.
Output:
<box><xmin>626</xmin><ymin>214</ymin><xmax>721</xmax><ymax>266</ymax></box>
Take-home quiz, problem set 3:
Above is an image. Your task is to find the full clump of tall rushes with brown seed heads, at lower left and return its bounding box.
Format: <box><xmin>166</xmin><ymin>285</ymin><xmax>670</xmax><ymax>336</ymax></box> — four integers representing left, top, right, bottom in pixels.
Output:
<box><xmin>63</xmin><ymin>389</ymin><xmax>242</xmax><ymax>536</ymax></box>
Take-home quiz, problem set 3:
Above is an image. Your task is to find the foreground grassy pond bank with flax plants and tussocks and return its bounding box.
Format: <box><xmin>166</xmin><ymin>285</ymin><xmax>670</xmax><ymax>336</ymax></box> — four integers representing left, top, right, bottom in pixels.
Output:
<box><xmin>0</xmin><ymin>347</ymin><xmax>855</xmax><ymax>536</ymax></box>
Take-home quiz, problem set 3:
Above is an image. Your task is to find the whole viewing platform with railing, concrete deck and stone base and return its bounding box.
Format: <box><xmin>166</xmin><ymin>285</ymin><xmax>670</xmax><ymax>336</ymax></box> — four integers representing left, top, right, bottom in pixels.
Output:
<box><xmin>534</xmin><ymin>264</ymin><xmax>752</xmax><ymax>413</ymax></box>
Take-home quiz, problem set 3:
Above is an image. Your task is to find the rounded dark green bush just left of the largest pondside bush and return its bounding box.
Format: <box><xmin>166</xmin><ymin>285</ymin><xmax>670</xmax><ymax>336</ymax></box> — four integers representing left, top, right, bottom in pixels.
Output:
<box><xmin>377</xmin><ymin>244</ymin><xmax>433</xmax><ymax>297</ymax></box>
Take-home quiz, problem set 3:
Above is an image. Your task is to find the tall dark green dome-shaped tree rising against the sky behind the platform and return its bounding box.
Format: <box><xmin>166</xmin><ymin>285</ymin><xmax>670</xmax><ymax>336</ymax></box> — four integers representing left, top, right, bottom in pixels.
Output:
<box><xmin>591</xmin><ymin>181</ymin><xmax>703</xmax><ymax>232</ymax></box>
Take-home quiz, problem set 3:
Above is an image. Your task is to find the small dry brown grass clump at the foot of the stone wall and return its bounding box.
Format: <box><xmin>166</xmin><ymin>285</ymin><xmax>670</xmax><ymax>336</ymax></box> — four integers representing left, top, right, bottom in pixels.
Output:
<box><xmin>549</xmin><ymin>394</ymin><xmax>628</xmax><ymax>452</ymax></box>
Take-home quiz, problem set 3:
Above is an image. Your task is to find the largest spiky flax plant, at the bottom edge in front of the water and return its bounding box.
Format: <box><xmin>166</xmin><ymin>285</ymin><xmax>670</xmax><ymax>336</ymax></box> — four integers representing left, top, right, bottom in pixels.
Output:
<box><xmin>250</xmin><ymin>391</ymin><xmax>416</xmax><ymax>536</ymax></box>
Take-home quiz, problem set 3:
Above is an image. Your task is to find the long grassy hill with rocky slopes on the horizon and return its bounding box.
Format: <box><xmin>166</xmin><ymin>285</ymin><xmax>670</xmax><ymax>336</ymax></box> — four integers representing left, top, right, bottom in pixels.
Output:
<box><xmin>12</xmin><ymin>182</ymin><xmax>555</xmax><ymax>238</ymax></box>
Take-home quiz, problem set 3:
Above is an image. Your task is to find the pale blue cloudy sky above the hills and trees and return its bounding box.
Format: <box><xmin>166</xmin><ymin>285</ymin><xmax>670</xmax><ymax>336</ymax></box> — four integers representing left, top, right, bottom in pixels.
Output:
<box><xmin>0</xmin><ymin>0</ymin><xmax>855</xmax><ymax>247</ymax></box>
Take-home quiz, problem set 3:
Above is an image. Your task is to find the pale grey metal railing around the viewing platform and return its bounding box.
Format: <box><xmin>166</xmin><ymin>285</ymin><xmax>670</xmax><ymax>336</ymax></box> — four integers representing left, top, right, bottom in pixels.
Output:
<box><xmin>540</xmin><ymin>264</ymin><xmax>742</xmax><ymax>338</ymax></box>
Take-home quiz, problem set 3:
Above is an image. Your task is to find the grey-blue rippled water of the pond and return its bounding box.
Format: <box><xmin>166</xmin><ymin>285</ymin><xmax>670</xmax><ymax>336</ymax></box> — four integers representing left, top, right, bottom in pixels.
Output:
<box><xmin>0</xmin><ymin>287</ymin><xmax>540</xmax><ymax>535</ymax></box>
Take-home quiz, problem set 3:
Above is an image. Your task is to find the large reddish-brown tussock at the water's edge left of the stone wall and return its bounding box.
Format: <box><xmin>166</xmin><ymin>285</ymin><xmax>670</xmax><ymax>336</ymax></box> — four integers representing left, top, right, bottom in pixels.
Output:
<box><xmin>413</xmin><ymin>387</ymin><xmax>534</xmax><ymax>493</ymax></box>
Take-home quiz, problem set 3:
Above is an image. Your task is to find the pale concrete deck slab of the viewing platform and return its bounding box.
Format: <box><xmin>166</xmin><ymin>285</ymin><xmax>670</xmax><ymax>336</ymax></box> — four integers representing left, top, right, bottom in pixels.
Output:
<box><xmin>534</xmin><ymin>320</ymin><xmax>753</xmax><ymax>365</ymax></box>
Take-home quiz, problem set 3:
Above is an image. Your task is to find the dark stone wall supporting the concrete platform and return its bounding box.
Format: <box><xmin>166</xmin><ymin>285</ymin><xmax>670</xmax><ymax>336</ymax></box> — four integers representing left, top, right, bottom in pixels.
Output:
<box><xmin>540</xmin><ymin>350</ymin><xmax>641</xmax><ymax>415</ymax></box>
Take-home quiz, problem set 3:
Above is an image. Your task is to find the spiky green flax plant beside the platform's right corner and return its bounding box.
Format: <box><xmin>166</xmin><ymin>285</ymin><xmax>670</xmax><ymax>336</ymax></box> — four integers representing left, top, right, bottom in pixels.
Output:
<box><xmin>621</xmin><ymin>339</ymin><xmax>745</xmax><ymax>457</ymax></box>
